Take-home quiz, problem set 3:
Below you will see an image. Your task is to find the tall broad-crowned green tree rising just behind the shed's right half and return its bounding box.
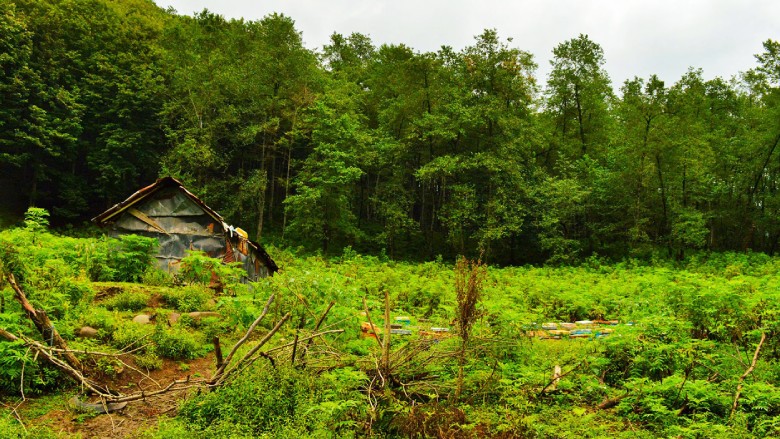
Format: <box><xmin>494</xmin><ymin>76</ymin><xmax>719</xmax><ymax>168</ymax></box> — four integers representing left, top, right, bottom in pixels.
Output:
<box><xmin>163</xmin><ymin>11</ymin><xmax>319</xmax><ymax>237</ymax></box>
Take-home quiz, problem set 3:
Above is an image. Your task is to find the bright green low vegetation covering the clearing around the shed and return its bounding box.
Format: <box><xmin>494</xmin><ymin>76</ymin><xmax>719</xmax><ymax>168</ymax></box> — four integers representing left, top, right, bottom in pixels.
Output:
<box><xmin>0</xmin><ymin>216</ymin><xmax>780</xmax><ymax>438</ymax></box>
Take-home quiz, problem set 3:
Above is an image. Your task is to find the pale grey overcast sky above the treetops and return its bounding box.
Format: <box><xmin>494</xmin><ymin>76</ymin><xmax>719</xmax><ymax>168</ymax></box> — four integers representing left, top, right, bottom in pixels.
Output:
<box><xmin>155</xmin><ymin>0</ymin><xmax>780</xmax><ymax>89</ymax></box>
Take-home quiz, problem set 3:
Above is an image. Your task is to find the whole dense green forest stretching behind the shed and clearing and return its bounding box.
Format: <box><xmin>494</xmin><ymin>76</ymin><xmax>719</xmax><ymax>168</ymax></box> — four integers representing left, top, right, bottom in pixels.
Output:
<box><xmin>0</xmin><ymin>0</ymin><xmax>780</xmax><ymax>265</ymax></box>
